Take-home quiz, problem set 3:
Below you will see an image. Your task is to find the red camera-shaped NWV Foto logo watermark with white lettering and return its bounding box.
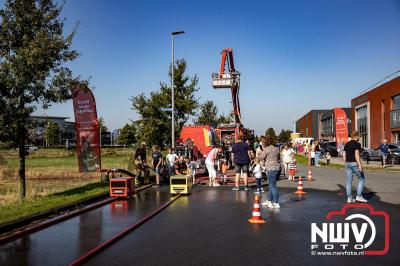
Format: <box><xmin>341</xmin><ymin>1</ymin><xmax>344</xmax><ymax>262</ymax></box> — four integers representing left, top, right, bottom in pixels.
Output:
<box><xmin>310</xmin><ymin>203</ymin><xmax>390</xmax><ymax>256</ymax></box>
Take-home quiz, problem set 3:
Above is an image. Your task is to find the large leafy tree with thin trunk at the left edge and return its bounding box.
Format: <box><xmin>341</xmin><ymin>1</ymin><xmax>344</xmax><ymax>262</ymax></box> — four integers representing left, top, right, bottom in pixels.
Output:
<box><xmin>0</xmin><ymin>0</ymin><xmax>80</xmax><ymax>200</ymax></box>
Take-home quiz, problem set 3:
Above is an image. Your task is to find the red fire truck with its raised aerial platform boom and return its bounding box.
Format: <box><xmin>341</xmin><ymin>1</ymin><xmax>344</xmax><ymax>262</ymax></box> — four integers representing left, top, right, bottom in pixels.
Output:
<box><xmin>176</xmin><ymin>48</ymin><xmax>254</xmax><ymax>165</ymax></box>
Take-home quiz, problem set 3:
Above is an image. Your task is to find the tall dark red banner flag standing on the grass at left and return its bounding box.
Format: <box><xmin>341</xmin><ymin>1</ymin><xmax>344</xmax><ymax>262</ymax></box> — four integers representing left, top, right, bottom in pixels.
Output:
<box><xmin>73</xmin><ymin>87</ymin><xmax>101</xmax><ymax>172</ymax></box>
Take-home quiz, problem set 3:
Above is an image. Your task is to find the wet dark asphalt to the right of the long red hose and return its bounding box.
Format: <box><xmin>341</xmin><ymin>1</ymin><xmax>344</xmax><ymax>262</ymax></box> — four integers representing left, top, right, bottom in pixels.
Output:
<box><xmin>87</xmin><ymin>187</ymin><xmax>400</xmax><ymax>265</ymax></box>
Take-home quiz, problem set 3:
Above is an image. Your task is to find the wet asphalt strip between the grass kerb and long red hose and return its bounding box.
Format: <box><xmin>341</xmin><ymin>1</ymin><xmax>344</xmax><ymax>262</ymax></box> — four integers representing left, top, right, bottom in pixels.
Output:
<box><xmin>0</xmin><ymin>187</ymin><xmax>175</xmax><ymax>265</ymax></box>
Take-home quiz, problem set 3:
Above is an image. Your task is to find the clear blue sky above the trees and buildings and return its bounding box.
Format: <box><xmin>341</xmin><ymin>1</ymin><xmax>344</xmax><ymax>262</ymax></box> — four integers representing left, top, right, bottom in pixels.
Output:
<box><xmin>3</xmin><ymin>0</ymin><xmax>400</xmax><ymax>134</ymax></box>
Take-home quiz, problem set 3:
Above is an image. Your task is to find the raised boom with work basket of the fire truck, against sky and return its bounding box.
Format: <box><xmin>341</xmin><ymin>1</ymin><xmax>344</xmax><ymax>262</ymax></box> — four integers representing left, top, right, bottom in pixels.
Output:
<box><xmin>212</xmin><ymin>48</ymin><xmax>242</xmax><ymax>126</ymax></box>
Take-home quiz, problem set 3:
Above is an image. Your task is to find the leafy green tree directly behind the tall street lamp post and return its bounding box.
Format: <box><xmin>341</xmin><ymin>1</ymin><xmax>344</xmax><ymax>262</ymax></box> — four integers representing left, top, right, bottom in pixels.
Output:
<box><xmin>131</xmin><ymin>59</ymin><xmax>199</xmax><ymax>146</ymax></box>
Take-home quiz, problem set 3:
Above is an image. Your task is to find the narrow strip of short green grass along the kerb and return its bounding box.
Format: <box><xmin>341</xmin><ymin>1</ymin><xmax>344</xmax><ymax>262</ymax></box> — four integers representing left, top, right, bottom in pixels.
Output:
<box><xmin>0</xmin><ymin>182</ymin><xmax>108</xmax><ymax>224</ymax></box>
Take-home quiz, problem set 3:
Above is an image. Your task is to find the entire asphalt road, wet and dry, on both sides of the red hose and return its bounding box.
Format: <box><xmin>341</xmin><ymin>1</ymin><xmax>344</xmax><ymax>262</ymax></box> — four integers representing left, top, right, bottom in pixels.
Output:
<box><xmin>0</xmin><ymin>167</ymin><xmax>400</xmax><ymax>265</ymax></box>
